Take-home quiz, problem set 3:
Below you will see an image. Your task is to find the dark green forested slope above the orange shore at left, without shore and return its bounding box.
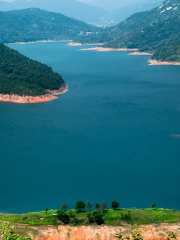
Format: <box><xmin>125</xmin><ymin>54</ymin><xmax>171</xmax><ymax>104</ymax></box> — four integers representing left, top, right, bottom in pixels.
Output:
<box><xmin>0</xmin><ymin>43</ymin><xmax>64</xmax><ymax>96</ymax></box>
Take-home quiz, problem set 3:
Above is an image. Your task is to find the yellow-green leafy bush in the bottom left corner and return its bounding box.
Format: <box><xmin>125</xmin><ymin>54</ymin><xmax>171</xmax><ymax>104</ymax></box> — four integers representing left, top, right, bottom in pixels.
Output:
<box><xmin>1</xmin><ymin>222</ymin><xmax>33</xmax><ymax>240</ymax></box>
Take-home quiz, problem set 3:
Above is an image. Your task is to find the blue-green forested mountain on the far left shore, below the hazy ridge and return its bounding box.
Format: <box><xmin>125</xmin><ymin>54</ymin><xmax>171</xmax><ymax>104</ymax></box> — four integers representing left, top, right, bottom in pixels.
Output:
<box><xmin>0</xmin><ymin>9</ymin><xmax>97</xmax><ymax>43</ymax></box>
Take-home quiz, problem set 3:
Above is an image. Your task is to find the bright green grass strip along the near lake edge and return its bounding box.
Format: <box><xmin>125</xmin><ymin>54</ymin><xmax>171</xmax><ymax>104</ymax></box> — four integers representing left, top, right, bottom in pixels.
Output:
<box><xmin>0</xmin><ymin>208</ymin><xmax>180</xmax><ymax>226</ymax></box>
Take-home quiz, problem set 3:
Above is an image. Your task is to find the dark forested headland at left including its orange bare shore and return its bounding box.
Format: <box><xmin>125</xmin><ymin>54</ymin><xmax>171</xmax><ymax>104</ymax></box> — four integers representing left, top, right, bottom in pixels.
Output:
<box><xmin>0</xmin><ymin>44</ymin><xmax>68</xmax><ymax>103</ymax></box>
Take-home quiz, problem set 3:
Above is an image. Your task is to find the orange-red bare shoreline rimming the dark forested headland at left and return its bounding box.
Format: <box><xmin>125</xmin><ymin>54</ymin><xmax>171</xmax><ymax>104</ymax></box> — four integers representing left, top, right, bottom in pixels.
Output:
<box><xmin>0</xmin><ymin>84</ymin><xmax>68</xmax><ymax>104</ymax></box>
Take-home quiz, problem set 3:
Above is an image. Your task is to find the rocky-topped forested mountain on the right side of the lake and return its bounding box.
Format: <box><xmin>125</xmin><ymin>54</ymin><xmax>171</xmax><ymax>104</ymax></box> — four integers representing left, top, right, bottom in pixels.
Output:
<box><xmin>81</xmin><ymin>0</ymin><xmax>180</xmax><ymax>61</ymax></box>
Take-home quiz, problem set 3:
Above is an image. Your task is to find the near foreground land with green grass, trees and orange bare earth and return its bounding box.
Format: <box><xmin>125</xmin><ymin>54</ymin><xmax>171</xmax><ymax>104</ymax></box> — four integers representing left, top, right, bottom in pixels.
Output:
<box><xmin>0</xmin><ymin>205</ymin><xmax>180</xmax><ymax>240</ymax></box>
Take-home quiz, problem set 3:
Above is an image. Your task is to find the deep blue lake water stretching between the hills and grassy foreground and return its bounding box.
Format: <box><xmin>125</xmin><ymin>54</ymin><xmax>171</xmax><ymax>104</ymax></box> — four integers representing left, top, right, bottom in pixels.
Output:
<box><xmin>0</xmin><ymin>42</ymin><xmax>180</xmax><ymax>213</ymax></box>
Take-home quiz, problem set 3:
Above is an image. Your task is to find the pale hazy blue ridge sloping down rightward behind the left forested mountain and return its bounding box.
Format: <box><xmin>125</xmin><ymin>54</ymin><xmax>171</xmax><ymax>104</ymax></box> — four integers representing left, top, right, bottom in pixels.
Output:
<box><xmin>0</xmin><ymin>0</ymin><xmax>111</xmax><ymax>25</ymax></box>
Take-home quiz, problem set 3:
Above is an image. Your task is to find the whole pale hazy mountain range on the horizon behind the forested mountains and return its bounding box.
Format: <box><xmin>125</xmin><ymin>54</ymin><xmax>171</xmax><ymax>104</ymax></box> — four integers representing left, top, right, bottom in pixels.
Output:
<box><xmin>0</xmin><ymin>0</ymin><xmax>163</xmax><ymax>26</ymax></box>
